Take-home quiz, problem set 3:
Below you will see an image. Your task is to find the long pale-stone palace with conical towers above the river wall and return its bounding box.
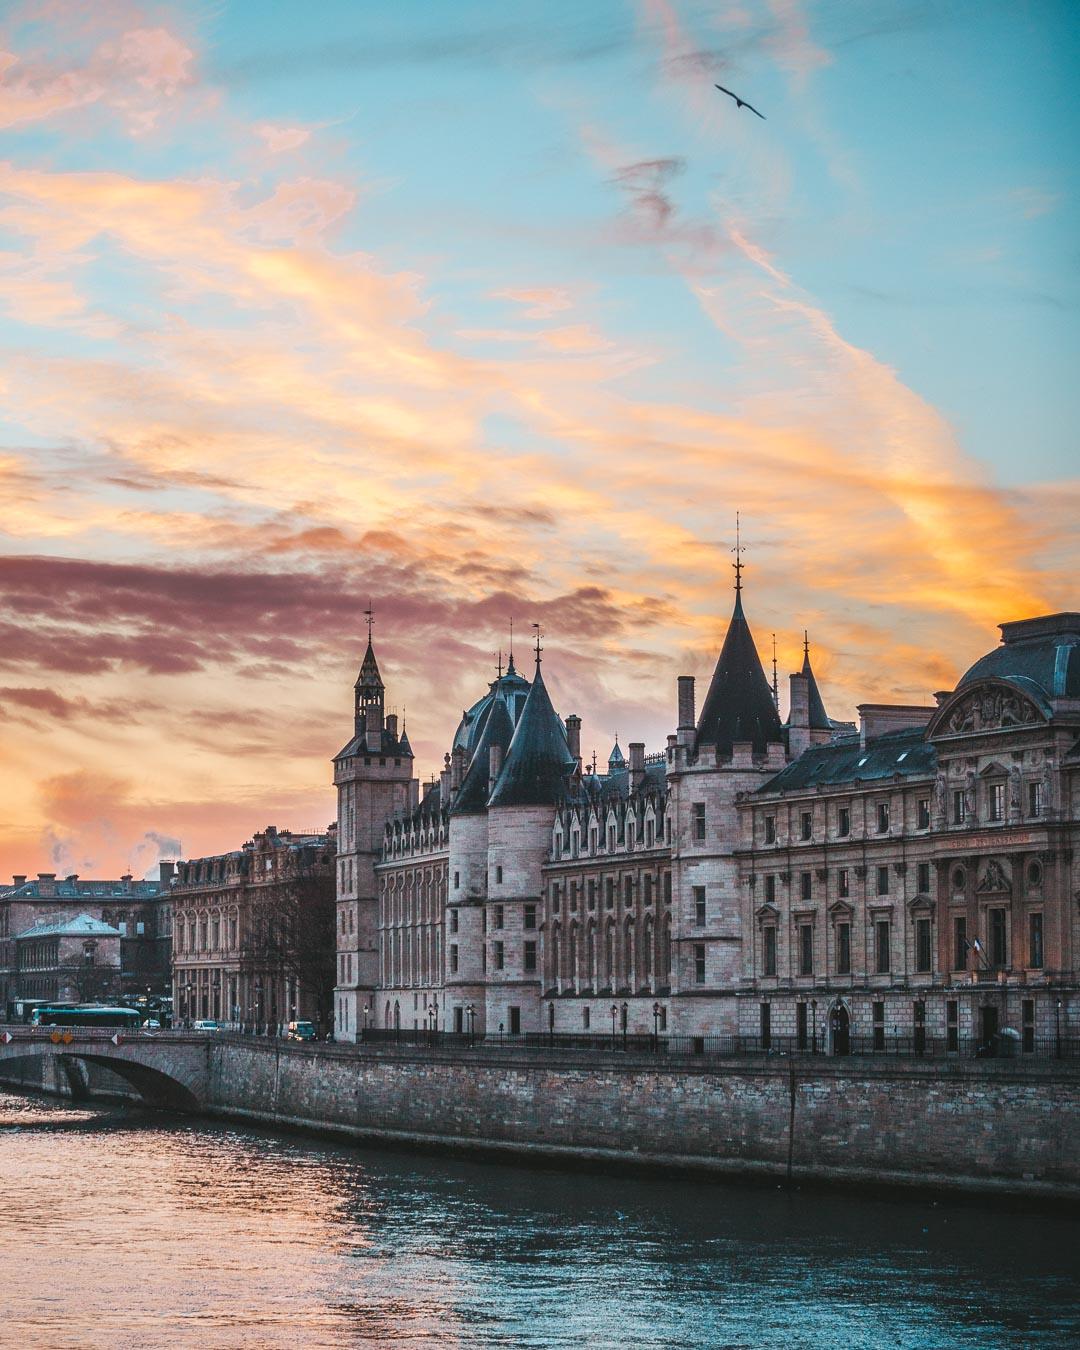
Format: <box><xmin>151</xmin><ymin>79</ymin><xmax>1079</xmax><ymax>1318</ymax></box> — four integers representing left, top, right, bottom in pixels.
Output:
<box><xmin>335</xmin><ymin>591</ymin><xmax>1080</xmax><ymax>1054</ymax></box>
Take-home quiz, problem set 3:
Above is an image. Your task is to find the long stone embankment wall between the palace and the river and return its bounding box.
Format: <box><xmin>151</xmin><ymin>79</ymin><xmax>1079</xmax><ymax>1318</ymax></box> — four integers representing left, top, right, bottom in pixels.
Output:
<box><xmin>207</xmin><ymin>1041</ymin><xmax>1080</xmax><ymax>1200</ymax></box>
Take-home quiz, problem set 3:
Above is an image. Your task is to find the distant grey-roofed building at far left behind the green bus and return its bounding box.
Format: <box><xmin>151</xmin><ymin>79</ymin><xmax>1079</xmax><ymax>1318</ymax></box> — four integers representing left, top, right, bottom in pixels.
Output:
<box><xmin>0</xmin><ymin>861</ymin><xmax>174</xmax><ymax>1010</ymax></box>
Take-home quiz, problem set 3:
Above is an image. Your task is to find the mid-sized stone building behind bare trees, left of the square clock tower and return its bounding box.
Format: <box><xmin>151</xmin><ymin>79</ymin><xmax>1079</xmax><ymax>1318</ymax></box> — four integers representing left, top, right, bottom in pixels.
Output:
<box><xmin>173</xmin><ymin>825</ymin><xmax>338</xmax><ymax>1031</ymax></box>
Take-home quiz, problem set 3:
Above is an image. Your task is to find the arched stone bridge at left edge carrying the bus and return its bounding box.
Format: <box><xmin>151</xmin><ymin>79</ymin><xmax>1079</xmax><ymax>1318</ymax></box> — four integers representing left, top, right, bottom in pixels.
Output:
<box><xmin>0</xmin><ymin>1025</ymin><xmax>213</xmax><ymax>1111</ymax></box>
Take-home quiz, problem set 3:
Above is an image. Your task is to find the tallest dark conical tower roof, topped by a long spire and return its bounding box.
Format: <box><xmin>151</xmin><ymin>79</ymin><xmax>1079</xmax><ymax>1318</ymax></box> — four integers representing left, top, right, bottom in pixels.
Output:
<box><xmin>694</xmin><ymin>583</ymin><xmax>782</xmax><ymax>755</ymax></box>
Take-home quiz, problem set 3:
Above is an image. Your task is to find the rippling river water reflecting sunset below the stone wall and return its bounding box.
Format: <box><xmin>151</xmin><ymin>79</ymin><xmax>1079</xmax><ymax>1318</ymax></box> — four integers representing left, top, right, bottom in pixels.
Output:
<box><xmin>0</xmin><ymin>1094</ymin><xmax>1080</xmax><ymax>1350</ymax></box>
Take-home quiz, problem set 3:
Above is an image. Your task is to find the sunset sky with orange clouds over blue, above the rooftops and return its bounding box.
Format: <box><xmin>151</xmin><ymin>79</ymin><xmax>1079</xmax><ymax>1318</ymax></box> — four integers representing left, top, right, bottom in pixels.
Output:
<box><xmin>0</xmin><ymin>0</ymin><xmax>1080</xmax><ymax>876</ymax></box>
